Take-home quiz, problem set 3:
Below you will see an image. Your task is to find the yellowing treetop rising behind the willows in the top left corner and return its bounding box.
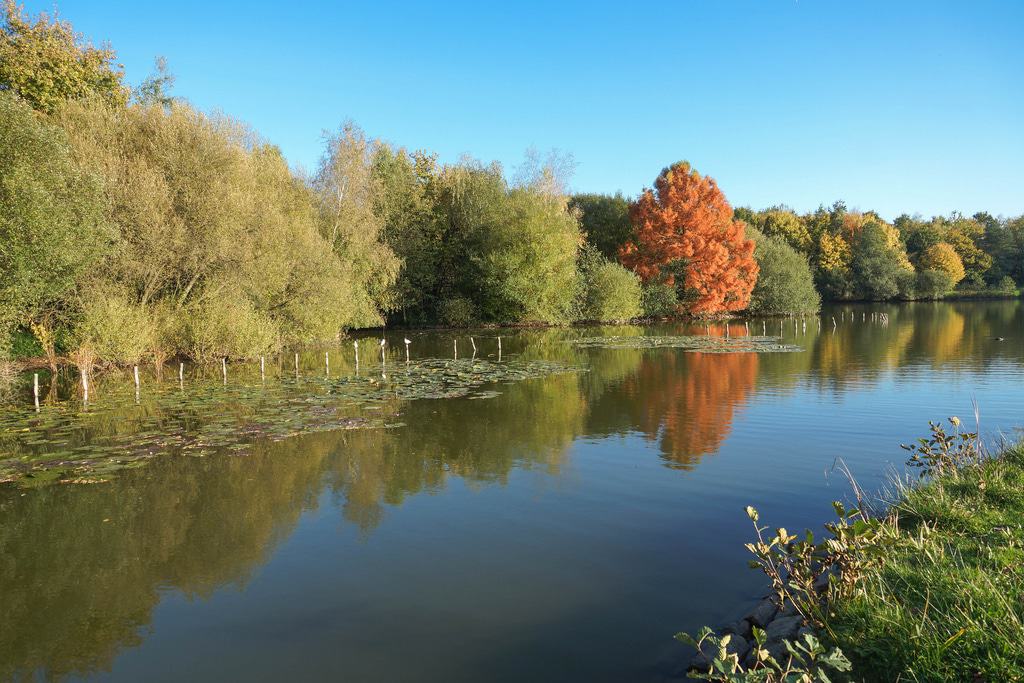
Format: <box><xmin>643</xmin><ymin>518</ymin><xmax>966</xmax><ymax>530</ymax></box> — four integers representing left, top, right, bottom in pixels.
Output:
<box><xmin>0</xmin><ymin>0</ymin><xmax>129</xmax><ymax>114</ymax></box>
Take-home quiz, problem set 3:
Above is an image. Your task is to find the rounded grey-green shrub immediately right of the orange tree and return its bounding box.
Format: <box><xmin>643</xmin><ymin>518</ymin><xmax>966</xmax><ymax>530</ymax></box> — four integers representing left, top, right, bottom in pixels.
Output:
<box><xmin>751</xmin><ymin>229</ymin><xmax>821</xmax><ymax>313</ymax></box>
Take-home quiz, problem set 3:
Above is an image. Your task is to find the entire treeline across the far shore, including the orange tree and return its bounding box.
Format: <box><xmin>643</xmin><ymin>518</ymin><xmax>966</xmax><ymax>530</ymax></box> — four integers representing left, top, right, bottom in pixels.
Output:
<box><xmin>0</xmin><ymin>0</ymin><xmax>1024</xmax><ymax>367</ymax></box>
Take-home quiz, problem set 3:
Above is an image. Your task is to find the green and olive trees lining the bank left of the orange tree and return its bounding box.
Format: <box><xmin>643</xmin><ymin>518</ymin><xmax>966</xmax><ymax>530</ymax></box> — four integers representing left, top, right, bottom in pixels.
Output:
<box><xmin>0</xmin><ymin>1</ymin><xmax>640</xmax><ymax>366</ymax></box>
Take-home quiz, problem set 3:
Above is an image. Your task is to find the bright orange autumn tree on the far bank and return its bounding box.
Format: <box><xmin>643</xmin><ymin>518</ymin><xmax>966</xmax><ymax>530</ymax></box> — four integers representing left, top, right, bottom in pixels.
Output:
<box><xmin>618</xmin><ymin>162</ymin><xmax>758</xmax><ymax>314</ymax></box>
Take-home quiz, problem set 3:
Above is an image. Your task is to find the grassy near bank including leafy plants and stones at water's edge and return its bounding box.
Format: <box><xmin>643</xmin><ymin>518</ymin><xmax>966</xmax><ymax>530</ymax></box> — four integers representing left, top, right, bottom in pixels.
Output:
<box><xmin>677</xmin><ymin>418</ymin><xmax>1024</xmax><ymax>682</ymax></box>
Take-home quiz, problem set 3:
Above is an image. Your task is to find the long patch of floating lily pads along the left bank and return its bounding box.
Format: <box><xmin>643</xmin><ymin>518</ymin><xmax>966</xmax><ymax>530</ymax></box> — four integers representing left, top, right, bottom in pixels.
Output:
<box><xmin>0</xmin><ymin>358</ymin><xmax>578</xmax><ymax>487</ymax></box>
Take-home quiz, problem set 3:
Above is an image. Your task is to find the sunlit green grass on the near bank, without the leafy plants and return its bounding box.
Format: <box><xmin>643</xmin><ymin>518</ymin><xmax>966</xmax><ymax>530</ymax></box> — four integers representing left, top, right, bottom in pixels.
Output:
<box><xmin>826</xmin><ymin>443</ymin><xmax>1024</xmax><ymax>682</ymax></box>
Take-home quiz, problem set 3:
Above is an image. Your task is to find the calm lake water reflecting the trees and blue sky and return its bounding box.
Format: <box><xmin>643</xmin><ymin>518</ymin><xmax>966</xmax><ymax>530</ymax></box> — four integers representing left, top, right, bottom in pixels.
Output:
<box><xmin>0</xmin><ymin>301</ymin><xmax>1024</xmax><ymax>682</ymax></box>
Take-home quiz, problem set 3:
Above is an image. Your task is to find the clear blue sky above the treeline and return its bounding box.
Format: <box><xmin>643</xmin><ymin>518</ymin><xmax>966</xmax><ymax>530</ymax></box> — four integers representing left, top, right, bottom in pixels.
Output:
<box><xmin>26</xmin><ymin>0</ymin><xmax>1024</xmax><ymax>218</ymax></box>
